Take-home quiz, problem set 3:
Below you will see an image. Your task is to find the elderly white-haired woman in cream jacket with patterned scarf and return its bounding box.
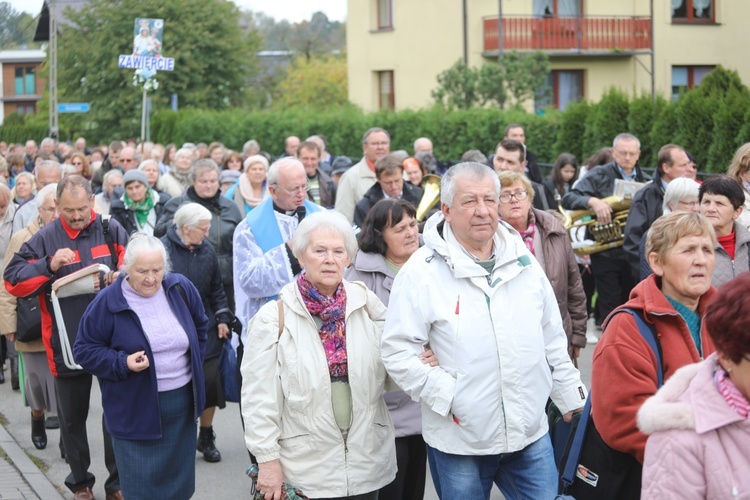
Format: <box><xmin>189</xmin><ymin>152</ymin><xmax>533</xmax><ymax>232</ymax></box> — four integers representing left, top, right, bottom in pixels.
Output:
<box><xmin>241</xmin><ymin>212</ymin><xmax>396</xmax><ymax>500</ymax></box>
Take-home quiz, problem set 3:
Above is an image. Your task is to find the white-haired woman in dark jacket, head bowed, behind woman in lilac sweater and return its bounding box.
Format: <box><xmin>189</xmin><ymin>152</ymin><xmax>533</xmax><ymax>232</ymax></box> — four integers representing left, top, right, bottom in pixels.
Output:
<box><xmin>161</xmin><ymin>203</ymin><xmax>233</xmax><ymax>462</ymax></box>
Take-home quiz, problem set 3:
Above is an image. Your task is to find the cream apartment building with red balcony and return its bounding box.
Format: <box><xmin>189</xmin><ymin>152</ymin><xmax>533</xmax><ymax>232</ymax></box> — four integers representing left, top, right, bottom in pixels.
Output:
<box><xmin>347</xmin><ymin>0</ymin><xmax>750</xmax><ymax>111</ymax></box>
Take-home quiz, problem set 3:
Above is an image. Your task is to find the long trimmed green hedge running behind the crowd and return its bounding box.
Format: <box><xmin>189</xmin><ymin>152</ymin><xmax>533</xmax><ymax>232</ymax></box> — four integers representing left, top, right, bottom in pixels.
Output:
<box><xmin>0</xmin><ymin>67</ymin><xmax>750</xmax><ymax>172</ymax></box>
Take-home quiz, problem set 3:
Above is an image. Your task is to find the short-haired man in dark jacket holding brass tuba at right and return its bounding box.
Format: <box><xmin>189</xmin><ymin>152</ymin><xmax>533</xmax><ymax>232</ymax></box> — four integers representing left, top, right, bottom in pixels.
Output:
<box><xmin>562</xmin><ymin>133</ymin><xmax>649</xmax><ymax>324</ymax></box>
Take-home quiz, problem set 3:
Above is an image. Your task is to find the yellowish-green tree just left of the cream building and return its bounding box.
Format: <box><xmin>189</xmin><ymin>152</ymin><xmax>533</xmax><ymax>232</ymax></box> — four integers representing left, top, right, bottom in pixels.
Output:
<box><xmin>274</xmin><ymin>56</ymin><xmax>347</xmax><ymax>108</ymax></box>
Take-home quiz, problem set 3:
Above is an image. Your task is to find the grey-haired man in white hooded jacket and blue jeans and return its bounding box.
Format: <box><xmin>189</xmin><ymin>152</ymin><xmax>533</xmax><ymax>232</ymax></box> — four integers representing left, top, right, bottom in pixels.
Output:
<box><xmin>381</xmin><ymin>163</ymin><xmax>586</xmax><ymax>499</ymax></box>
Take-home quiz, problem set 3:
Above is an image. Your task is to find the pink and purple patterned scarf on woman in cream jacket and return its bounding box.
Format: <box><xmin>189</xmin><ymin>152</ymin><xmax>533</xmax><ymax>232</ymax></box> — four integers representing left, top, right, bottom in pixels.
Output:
<box><xmin>297</xmin><ymin>273</ymin><xmax>349</xmax><ymax>377</ymax></box>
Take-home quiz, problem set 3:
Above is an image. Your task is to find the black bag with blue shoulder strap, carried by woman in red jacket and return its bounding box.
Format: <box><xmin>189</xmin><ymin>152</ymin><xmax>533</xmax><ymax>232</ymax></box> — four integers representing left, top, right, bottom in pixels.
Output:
<box><xmin>558</xmin><ymin>309</ymin><xmax>664</xmax><ymax>500</ymax></box>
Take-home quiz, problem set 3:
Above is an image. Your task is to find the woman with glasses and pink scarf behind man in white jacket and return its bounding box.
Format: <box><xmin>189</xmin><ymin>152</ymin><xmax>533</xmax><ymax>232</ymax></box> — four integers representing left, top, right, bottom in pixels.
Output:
<box><xmin>498</xmin><ymin>171</ymin><xmax>588</xmax><ymax>362</ymax></box>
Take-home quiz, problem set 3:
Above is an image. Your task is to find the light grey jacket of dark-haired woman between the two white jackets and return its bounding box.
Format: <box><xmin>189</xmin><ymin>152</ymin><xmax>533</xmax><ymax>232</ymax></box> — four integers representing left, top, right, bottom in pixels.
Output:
<box><xmin>344</xmin><ymin>252</ymin><xmax>422</xmax><ymax>438</ymax></box>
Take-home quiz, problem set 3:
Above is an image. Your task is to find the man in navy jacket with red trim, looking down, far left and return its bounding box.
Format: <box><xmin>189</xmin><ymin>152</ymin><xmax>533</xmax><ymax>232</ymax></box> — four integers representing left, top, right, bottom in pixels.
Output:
<box><xmin>3</xmin><ymin>174</ymin><xmax>128</xmax><ymax>500</ymax></box>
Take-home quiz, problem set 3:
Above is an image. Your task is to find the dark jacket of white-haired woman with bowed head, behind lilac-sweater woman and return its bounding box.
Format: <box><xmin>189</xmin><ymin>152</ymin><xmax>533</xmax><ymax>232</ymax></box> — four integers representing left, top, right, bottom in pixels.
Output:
<box><xmin>161</xmin><ymin>226</ymin><xmax>232</xmax><ymax>359</ymax></box>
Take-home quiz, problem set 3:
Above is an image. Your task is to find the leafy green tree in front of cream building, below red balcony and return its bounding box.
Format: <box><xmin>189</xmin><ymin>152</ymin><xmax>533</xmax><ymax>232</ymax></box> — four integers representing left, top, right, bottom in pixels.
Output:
<box><xmin>432</xmin><ymin>51</ymin><xmax>550</xmax><ymax>109</ymax></box>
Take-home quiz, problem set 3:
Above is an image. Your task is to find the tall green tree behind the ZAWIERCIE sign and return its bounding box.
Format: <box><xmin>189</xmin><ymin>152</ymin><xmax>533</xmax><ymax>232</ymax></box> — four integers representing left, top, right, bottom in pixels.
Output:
<box><xmin>58</xmin><ymin>0</ymin><xmax>260</xmax><ymax>141</ymax></box>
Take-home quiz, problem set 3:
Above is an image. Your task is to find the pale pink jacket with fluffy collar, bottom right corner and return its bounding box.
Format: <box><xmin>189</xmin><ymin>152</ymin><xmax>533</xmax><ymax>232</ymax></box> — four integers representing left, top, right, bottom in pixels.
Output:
<box><xmin>638</xmin><ymin>354</ymin><xmax>750</xmax><ymax>500</ymax></box>
